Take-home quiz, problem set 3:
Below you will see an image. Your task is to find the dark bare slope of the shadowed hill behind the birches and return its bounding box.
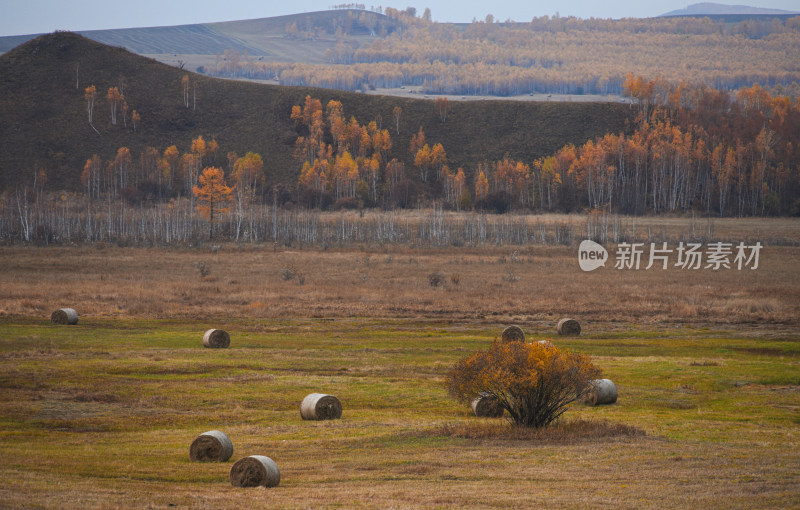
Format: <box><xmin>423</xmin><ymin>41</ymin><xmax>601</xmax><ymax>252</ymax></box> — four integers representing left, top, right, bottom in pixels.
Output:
<box><xmin>0</xmin><ymin>32</ymin><xmax>632</xmax><ymax>191</ymax></box>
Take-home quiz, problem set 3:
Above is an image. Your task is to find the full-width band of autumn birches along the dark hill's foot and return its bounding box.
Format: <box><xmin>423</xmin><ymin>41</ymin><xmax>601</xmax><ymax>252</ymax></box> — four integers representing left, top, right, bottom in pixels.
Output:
<box><xmin>0</xmin><ymin>78</ymin><xmax>800</xmax><ymax>247</ymax></box>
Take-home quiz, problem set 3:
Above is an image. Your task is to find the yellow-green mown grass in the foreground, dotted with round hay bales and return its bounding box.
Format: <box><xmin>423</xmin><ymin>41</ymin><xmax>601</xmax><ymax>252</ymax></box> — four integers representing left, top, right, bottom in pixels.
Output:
<box><xmin>0</xmin><ymin>318</ymin><xmax>800</xmax><ymax>508</ymax></box>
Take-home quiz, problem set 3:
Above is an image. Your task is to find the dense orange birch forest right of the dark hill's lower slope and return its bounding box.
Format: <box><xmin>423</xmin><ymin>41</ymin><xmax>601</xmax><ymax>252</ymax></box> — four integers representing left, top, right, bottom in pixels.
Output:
<box><xmin>475</xmin><ymin>74</ymin><xmax>800</xmax><ymax>216</ymax></box>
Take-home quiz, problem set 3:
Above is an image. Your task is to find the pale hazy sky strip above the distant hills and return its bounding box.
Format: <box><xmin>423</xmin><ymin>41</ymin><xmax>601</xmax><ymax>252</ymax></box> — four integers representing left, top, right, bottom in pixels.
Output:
<box><xmin>0</xmin><ymin>0</ymin><xmax>800</xmax><ymax>36</ymax></box>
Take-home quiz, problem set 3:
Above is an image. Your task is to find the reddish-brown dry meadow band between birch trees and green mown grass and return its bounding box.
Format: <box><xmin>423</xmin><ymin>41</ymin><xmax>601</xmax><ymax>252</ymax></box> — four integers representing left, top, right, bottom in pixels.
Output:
<box><xmin>0</xmin><ymin>235</ymin><xmax>800</xmax><ymax>327</ymax></box>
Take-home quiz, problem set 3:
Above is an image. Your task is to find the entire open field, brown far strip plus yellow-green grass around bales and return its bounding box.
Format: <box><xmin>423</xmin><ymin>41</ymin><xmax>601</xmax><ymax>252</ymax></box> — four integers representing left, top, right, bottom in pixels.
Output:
<box><xmin>0</xmin><ymin>226</ymin><xmax>800</xmax><ymax>509</ymax></box>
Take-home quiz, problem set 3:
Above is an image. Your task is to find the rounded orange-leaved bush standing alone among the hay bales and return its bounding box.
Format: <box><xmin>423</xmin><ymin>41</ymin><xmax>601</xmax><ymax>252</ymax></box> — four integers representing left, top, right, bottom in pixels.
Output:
<box><xmin>445</xmin><ymin>340</ymin><xmax>601</xmax><ymax>428</ymax></box>
